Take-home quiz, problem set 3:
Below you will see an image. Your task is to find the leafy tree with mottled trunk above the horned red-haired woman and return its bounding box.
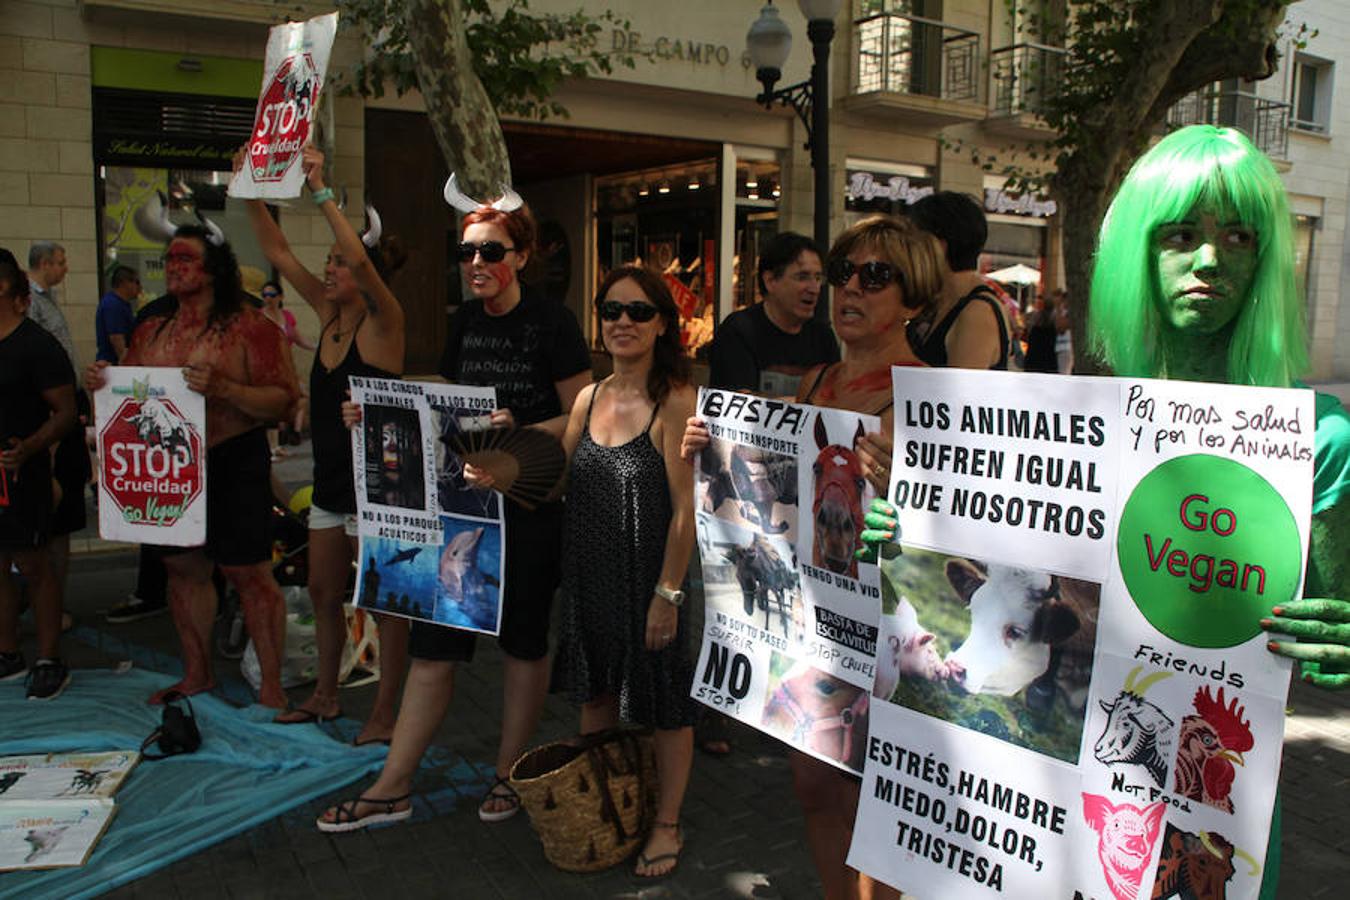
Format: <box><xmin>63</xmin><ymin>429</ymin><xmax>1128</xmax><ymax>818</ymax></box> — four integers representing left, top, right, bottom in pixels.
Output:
<box><xmin>338</xmin><ymin>0</ymin><xmax>633</xmax><ymax>198</ymax></box>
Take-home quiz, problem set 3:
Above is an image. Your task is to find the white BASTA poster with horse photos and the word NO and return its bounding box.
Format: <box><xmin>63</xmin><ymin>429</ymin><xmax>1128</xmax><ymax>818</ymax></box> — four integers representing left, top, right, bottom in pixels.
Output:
<box><xmin>691</xmin><ymin>389</ymin><xmax>880</xmax><ymax>772</ymax></box>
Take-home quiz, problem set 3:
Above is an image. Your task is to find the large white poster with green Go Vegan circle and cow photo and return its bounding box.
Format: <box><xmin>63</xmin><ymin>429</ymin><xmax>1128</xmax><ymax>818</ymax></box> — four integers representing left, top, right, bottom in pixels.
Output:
<box><xmin>849</xmin><ymin>370</ymin><xmax>1314</xmax><ymax>900</ymax></box>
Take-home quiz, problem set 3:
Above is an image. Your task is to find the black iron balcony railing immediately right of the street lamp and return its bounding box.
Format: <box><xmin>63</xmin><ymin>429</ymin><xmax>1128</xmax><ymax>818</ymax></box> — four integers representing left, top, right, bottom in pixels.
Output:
<box><xmin>853</xmin><ymin>12</ymin><xmax>980</xmax><ymax>101</ymax></box>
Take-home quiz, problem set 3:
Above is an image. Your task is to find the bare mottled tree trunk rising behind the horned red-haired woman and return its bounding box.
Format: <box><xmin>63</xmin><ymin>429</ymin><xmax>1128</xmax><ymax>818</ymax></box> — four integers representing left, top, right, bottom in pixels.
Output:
<box><xmin>400</xmin><ymin>0</ymin><xmax>510</xmax><ymax>201</ymax></box>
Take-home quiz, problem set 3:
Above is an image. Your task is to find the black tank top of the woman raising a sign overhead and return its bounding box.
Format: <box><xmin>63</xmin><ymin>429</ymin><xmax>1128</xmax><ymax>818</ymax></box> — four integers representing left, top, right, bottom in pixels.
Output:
<box><xmin>309</xmin><ymin>319</ymin><xmax>398</xmax><ymax>513</ymax></box>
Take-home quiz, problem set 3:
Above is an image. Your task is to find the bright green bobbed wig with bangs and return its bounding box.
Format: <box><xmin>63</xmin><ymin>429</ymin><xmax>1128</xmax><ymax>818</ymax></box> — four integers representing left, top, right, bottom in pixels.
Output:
<box><xmin>1088</xmin><ymin>125</ymin><xmax>1308</xmax><ymax>387</ymax></box>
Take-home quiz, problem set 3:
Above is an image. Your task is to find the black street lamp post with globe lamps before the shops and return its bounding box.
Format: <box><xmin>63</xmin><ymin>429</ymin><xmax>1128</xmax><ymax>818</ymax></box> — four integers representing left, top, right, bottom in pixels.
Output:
<box><xmin>745</xmin><ymin>0</ymin><xmax>841</xmax><ymax>260</ymax></box>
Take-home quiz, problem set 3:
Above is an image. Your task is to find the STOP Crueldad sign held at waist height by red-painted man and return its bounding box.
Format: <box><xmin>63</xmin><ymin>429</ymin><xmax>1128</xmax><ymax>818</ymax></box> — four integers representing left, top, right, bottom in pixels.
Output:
<box><xmin>95</xmin><ymin>366</ymin><xmax>209</xmax><ymax>546</ymax></box>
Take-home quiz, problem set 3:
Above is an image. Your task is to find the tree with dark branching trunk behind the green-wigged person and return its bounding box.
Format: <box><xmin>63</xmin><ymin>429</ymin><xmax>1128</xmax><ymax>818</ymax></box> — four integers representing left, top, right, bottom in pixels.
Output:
<box><xmin>972</xmin><ymin>0</ymin><xmax>1296</xmax><ymax>371</ymax></box>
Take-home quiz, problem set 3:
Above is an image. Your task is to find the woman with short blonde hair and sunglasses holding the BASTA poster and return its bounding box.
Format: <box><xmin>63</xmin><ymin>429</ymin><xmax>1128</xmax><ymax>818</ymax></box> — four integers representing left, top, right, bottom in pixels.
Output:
<box><xmin>683</xmin><ymin>216</ymin><xmax>946</xmax><ymax>900</ymax></box>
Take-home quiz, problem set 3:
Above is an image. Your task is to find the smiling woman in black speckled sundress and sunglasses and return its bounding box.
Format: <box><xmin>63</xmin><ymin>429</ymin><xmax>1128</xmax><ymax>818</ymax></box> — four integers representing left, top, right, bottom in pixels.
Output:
<box><xmin>554</xmin><ymin>266</ymin><xmax>698</xmax><ymax>877</ymax></box>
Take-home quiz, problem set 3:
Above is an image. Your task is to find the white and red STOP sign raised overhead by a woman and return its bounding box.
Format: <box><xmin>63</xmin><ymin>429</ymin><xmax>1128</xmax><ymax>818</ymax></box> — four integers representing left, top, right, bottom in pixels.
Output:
<box><xmin>230</xmin><ymin>12</ymin><xmax>338</xmax><ymax>200</ymax></box>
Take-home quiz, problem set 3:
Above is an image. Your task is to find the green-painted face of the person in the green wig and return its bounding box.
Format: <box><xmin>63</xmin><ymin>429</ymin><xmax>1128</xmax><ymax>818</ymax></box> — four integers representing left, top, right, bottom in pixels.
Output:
<box><xmin>1153</xmin><ymin>200</ymin><xmax>1257</xmax><ymax>335</ymax></box>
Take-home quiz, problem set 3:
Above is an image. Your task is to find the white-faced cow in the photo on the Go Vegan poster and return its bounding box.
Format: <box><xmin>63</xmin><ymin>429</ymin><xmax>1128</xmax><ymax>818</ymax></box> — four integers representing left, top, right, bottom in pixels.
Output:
<box><xmin>946</xmin><ymin>559</ymin><xmax>1098</xmax><ymax>711</ymax></box>
